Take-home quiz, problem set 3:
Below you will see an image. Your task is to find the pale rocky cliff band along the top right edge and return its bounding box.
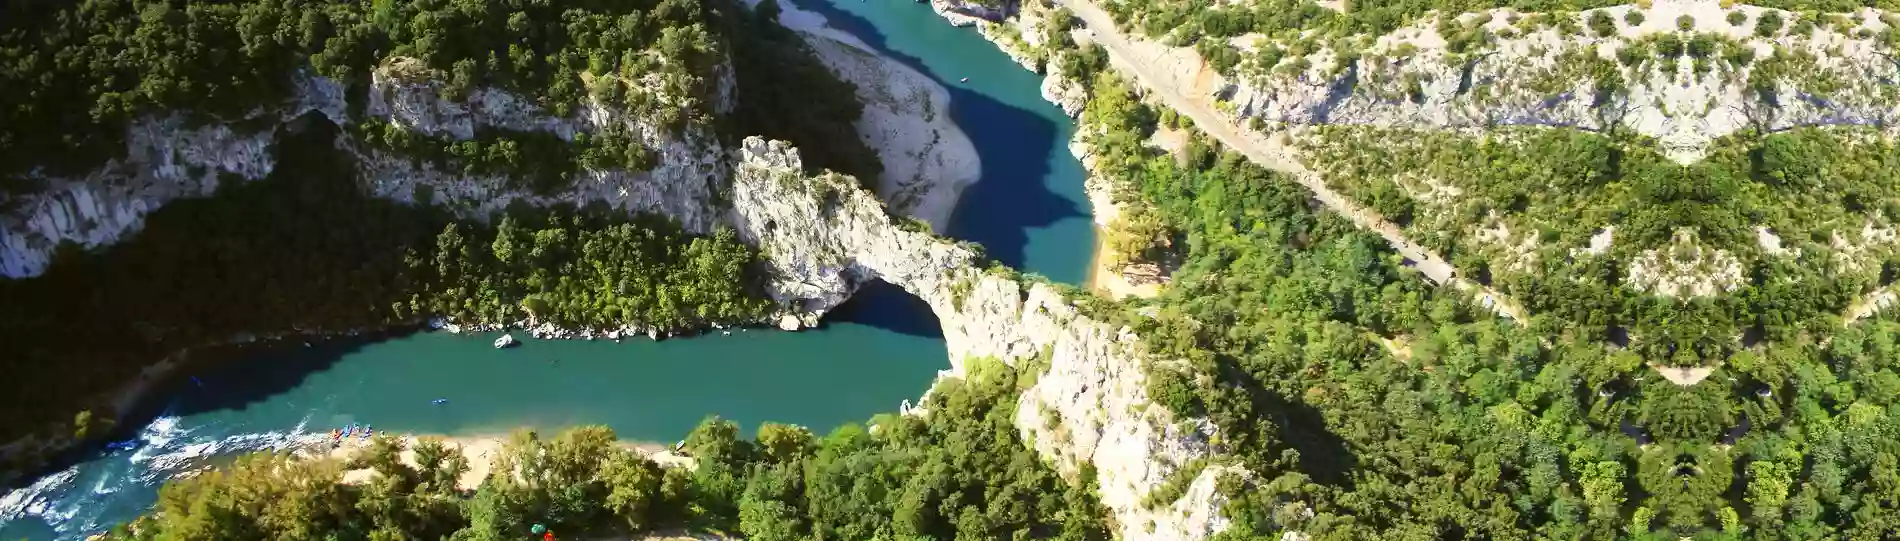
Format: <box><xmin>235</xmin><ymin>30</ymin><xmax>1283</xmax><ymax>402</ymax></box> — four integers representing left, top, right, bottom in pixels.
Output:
<box><xmin>1216</xmin><ymin>0</ymin><xmax>1900</xmax><ymax>163</ymax></box>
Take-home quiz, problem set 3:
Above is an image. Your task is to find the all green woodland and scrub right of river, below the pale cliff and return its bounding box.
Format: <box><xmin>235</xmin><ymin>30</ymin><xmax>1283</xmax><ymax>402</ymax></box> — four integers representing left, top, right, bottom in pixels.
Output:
<box><xmin>1081</xmin><ymin>13</ymin><xmax>1900</xmax><ymax>539</ymax></box>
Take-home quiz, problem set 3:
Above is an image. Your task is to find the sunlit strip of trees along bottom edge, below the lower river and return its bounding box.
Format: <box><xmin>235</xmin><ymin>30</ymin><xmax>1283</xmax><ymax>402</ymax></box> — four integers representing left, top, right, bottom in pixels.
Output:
<box><xmin>108</xmin><ymin>361</ymin><xmax>1110</xmax><ymax>541</ymax></box>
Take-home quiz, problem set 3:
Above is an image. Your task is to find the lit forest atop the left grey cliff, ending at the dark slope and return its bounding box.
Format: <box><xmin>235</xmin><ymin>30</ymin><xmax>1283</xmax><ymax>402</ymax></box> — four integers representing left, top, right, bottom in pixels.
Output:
<box><xmin>0</xmin><ymin>0</ymin><xmax>726</xmax><ymax>190</ymax></box>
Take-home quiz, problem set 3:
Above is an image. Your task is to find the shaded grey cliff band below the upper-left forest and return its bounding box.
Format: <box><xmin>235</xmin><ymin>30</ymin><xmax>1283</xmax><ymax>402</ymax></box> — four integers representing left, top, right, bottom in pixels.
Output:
<box><xmin>0</xmin><ymin>63</ymin><xmax>733</xmax><ymax>277</ymax></box>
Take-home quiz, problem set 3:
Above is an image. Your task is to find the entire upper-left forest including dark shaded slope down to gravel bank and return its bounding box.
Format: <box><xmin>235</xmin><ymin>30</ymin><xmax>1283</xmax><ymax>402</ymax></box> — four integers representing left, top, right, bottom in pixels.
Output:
<box><xmin>0</xmin><ymin>0</ymin><xmax>882</xmax><ymax>194</ymax></box>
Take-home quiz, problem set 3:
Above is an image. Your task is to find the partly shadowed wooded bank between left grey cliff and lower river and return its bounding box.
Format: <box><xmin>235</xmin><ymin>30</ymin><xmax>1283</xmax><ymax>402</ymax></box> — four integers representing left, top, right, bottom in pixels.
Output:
<box><xmin>0</xmin><ymin>116</ymin><xmax>770</xmax><ymax>463</ymax></box>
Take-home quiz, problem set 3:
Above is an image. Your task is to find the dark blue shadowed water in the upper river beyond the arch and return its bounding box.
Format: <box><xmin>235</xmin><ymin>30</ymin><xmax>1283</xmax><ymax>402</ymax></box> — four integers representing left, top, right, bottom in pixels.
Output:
<box><xmin>798</xmin><ymin>0</ymin><xmax>1093</xmax><ymax>283</ymax></box>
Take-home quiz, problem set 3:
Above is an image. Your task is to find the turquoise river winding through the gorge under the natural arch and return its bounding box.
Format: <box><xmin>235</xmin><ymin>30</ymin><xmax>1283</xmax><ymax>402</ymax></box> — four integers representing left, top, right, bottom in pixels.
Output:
<box><xmin>0</xmin><ymin>0</ymin><xmax>1094</xmax><ymax>539</ymax></box>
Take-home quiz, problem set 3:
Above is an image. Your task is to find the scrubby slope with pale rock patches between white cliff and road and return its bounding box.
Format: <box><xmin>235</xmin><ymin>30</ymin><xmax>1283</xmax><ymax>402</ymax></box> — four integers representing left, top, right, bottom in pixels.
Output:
<box><xmin>1307</xmin><ymin>127</ymin><xmax>1900</xmax><ymax>366</ymax></box>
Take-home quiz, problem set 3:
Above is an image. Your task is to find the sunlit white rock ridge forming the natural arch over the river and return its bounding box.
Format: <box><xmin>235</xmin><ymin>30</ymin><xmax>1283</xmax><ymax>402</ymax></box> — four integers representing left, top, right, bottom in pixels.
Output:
<box><xmin>732</xmin><ymin>139</ymin><xmax>1224</xmax><ymax>539</ymax></box>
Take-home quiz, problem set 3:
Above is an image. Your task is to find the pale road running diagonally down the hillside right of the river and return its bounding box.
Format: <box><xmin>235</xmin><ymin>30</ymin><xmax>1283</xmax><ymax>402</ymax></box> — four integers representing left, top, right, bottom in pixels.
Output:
<box><xmin>1062</xmin><ymin>0</ymin><xmax>1526</xmax><ymax>323</ymax></box>
